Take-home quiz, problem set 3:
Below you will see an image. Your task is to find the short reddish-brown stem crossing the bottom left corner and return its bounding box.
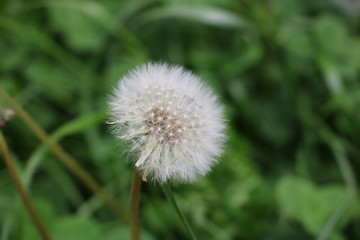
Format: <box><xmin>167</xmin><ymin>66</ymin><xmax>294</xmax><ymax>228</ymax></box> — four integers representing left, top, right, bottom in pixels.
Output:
<box><xmin>0</xmin><ymin>131</ymin><xmax>51</xmax><ymax>240</ymax></box>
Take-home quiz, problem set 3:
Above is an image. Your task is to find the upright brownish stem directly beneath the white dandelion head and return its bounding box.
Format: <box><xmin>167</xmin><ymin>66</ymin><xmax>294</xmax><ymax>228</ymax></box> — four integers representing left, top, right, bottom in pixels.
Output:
<box><xmin>130</xmin><ymin>168</ymin><xmax>141</xmax><ymax>240</ymax></box>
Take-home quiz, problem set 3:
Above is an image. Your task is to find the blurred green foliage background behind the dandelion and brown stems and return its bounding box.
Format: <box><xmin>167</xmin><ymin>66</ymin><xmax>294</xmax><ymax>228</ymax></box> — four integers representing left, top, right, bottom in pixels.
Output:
<box><xmin>0</xmin><ymin>0</ymin><xmax>360</xmax><ymax>240</ymax></box>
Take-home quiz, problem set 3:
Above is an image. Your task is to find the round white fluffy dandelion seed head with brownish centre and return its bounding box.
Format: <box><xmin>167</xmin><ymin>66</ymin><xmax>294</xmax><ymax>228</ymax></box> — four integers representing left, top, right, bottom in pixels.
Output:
<box><xmin>109</xmin><ymin>63</ymin><xmax>226</xmax><ymax>183</ymax></box>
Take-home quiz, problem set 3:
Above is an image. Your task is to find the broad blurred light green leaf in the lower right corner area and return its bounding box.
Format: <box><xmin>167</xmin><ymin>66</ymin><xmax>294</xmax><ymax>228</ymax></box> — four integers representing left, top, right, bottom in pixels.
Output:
<box><xmin>276</xmin><ymin>176</ymin><xmax>352</xmax><ymax>236</ymax></box>
